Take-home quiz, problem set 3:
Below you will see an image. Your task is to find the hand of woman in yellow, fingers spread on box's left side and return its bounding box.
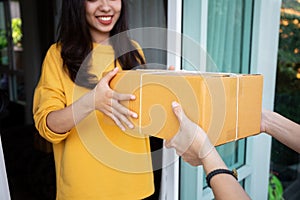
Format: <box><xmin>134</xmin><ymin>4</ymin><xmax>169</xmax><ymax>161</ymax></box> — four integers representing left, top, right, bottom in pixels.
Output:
<box><xmin>94</xmin><ymin>67</ymin><xmax>138</xmax><ymax>131</ymax></box>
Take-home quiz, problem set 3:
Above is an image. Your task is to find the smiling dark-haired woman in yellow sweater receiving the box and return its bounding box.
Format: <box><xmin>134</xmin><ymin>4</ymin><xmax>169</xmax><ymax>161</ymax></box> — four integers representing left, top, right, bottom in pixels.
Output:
<box><xmin>33</xmin><ymin>0</ymin><xmax>154</xmax><ymax>200</ymax></box>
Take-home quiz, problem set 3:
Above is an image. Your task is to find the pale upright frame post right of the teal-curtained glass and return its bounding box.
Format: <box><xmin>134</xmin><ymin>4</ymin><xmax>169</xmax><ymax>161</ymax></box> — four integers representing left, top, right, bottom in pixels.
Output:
<box><xmin>245</xmin><ymin>0</ymin><xmax>281</xmax><ymax>199</ymax></box>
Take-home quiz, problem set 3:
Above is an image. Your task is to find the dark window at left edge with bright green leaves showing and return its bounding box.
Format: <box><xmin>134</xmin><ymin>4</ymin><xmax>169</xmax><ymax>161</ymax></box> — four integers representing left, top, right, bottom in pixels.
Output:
<box><xmin>0</xmin><ymin>0</ymin><xmax>25</xmax><ymax>104</ymax></box>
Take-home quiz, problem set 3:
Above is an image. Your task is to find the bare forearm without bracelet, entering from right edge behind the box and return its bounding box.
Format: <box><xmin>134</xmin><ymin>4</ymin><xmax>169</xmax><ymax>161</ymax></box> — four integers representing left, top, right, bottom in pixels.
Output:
<box><xmin>261</xmin><ymin>110</ymin><xmax>300</xmax><ymax>153</ymax></box>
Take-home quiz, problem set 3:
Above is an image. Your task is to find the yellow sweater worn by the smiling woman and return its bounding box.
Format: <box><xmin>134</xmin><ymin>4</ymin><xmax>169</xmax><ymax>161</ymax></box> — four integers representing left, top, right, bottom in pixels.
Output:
<box><xmin>33</xmin><ymin>44</ymin><xmax>154</xmax><ymax>200</ymax></box>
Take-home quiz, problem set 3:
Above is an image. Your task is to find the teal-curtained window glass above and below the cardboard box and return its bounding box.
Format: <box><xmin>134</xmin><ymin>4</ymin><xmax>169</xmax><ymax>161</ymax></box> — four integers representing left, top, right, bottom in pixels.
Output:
<box><xmin>204</xmin><ymin>0</ymin><xmax>253</xmax><ymax>189</ymax></box>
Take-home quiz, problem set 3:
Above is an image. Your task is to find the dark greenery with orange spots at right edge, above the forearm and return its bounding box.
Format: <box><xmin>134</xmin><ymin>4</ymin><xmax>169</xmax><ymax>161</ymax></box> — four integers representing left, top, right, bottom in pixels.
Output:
<box><xmin>275</xmin><ymin>10</ymin><xmax>300</xmax><ymax>123</ymax></box>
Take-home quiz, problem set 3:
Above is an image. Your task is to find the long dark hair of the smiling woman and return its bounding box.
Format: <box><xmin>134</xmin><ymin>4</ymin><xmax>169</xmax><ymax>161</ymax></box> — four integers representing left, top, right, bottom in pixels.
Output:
<box><xmin>57</xmin><ymin>0</ymin><xmax>145</xmax><ymax>88</ymax></box>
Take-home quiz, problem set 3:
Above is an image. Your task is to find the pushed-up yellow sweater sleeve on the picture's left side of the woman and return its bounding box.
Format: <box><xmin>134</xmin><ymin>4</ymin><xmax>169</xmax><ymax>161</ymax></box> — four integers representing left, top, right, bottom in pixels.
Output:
<box><xmin>33</xmin><ymin>44</ymin><xmax>69</xmax><ymax>144</ymax></box>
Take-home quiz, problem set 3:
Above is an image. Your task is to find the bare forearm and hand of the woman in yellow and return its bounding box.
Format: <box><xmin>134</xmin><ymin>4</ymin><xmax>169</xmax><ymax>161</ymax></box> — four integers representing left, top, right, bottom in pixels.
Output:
<box><xmin>47</xmin><ymin>68</ymin><xmax>137</xmax><ymax>133</ymax></box>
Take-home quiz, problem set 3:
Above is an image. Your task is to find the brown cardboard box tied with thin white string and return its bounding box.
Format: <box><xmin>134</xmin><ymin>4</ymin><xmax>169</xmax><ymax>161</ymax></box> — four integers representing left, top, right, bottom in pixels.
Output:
<box><xmin>110</xmin><ymin>70</ymin><xmax>263</xmax><ymax>146</ymax></box>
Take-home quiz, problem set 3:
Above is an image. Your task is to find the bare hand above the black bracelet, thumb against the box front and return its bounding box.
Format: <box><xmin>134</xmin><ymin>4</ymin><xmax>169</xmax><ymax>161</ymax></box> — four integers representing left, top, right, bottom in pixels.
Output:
<box><xmin>165</xmin><ymin>102</ymin><xmax>214</xmax><ymax>166</ymax></box>
